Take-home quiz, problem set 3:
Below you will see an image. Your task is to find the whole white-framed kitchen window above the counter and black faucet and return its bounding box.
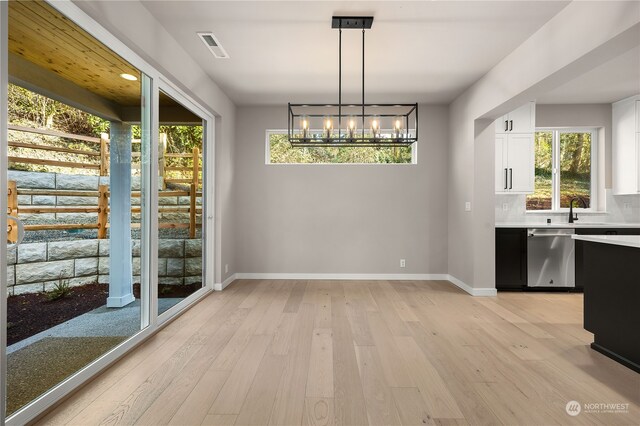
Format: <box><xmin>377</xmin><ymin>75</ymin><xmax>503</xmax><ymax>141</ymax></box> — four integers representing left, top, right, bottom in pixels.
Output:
<box><xmin>527</xmin><ymin>128</ymin><xmax>597</xmax><ymax>211</ymax></box>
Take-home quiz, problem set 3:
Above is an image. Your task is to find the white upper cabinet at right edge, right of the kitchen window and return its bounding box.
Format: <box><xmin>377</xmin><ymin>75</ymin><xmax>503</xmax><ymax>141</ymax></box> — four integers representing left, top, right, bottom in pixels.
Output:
<box><xmin>612</xmin><ymin>95</ymin><xmax>640</xmax><ymax>195</ymax></box>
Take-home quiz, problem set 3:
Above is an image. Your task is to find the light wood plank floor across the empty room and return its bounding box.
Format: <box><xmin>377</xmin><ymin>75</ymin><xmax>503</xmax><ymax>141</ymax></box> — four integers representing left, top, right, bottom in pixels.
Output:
<box><xmin>41</xmin><ymin>280</ymin><xmax>640</xmax><ymax>425</ymax></box>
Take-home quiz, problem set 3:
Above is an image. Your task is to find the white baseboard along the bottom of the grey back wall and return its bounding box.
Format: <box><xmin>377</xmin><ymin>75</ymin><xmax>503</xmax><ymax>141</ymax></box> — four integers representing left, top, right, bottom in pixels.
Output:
<box><xmin>220</xmin><ymin>272</ymin><xmax>497</xmax><ymax>296</ymax></box>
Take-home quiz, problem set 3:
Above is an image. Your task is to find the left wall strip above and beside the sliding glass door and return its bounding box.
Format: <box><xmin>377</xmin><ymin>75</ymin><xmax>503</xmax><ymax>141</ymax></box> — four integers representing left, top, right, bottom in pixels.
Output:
<box><xmin>74</xmin><ymin>1</ymin><xmax>236</xmax><ymax>282</ymax></box>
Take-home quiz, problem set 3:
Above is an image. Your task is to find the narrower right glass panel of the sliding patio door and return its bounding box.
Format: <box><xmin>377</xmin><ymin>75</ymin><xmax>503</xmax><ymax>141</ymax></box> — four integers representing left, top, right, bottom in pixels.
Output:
<box><xmin>157</xmin><ymin>91</ymin><xmax>204</xmax><ymax>314</ymax></box>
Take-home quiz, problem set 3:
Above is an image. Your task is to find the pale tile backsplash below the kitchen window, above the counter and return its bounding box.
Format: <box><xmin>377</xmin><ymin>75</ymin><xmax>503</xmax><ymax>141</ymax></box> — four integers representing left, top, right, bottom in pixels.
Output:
<box><xmin>495</xmin><ymin>189</ymin><xmax>640</xmax><ymax>224</ymax></box>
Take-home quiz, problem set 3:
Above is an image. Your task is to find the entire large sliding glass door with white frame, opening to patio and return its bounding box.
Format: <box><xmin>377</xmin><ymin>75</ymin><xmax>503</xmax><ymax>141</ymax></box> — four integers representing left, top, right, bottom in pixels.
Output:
<box><xmin>0</xmin><ymin>0</ymin><xmax>214</xmax><ymax>424</ymax></box>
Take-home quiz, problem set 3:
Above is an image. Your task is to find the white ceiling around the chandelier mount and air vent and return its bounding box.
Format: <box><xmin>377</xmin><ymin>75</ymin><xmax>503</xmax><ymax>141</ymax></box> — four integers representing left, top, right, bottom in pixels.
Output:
<box><xmin>143</xmin><ymin>1</ymin><xmax>568</xmax><ymax>105</ymax></box>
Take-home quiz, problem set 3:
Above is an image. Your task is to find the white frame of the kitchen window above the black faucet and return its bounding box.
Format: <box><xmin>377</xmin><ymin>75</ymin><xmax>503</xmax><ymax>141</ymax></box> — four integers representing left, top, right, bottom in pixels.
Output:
<box><xmin>525</xmin><ymin>126</ymin><xmax>599</xmax><ymax>214</ymax></box>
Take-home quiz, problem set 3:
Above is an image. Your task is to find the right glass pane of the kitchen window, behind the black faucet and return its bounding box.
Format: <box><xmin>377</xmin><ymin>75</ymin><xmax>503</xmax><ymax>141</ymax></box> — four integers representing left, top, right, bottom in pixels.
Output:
<box><xmin>560</xmin><ymin>132</ymin><xmax>591</xmax><ymax>208</ymax></box>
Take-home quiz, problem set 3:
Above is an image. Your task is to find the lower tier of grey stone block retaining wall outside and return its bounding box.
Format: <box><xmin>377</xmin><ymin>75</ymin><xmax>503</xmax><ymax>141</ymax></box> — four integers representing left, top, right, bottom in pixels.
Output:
<box><xmin>7</xmin><ymin>239</ymin><xmax>202</xmax><ymax>295</ymax></box>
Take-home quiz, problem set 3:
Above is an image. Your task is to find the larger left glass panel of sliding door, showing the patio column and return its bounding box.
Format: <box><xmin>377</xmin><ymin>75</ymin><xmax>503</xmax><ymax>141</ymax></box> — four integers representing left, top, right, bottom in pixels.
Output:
<box><xmin>2</xmin><ymin>1</ymin><xmax>149</xmax><ymax>415</ymax></box>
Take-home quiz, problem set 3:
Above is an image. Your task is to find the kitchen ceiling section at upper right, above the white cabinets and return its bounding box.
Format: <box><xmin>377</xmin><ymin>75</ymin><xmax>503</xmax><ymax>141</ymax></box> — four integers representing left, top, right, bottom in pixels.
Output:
<box><xmin>536</xmin><ymin>45</ymin><xmax>640</xmax><ymax>104</ymax></box>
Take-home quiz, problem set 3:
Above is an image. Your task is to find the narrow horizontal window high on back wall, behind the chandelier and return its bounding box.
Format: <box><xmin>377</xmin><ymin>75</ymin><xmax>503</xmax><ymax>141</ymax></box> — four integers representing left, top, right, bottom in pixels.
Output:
<box><xmin>265</xmin><ymin>130</ymin><xmax>417</xmax><ymax>164</ymax></box>
